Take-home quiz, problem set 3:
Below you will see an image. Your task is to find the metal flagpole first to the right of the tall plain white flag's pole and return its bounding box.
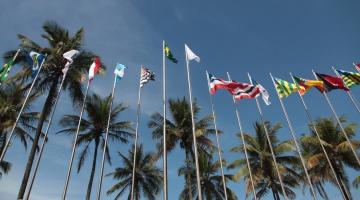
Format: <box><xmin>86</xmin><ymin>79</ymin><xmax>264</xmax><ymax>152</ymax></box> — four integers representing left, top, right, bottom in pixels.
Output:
<box><xmin>206</xmin><ymin>70</ymin><xmax>228</xmax><ymax>200</ymax></box>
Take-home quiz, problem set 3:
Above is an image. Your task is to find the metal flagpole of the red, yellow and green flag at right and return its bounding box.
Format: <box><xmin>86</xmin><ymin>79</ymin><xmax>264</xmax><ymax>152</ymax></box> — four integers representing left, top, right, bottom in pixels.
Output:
<box><xmin>290</xmin><ymin>72</ymin><xmax>346</xmax><ymax>199</ymax></box>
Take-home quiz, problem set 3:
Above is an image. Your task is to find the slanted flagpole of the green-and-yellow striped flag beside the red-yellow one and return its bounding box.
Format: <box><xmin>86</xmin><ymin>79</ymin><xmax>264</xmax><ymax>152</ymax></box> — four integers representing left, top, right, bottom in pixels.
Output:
<box><xmin>270</xmin><ymin>73</ymin><xmax>317</xmax><ymax>200</ymax></box>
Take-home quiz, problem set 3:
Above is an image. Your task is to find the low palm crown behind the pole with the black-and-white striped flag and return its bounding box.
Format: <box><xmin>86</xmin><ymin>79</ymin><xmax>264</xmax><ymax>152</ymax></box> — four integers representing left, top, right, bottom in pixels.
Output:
<box><xmin>107</xmin><ymin>145</ymin><xmax>162</xmax><ymax>200</ymax></box>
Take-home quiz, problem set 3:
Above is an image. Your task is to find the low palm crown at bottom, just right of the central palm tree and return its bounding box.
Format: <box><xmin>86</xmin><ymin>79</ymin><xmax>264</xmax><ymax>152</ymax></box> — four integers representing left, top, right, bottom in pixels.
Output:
<box><xmin>179</xmin><ymin>152</ymin><xmax>237</xmax><ymax>200</ymax></box>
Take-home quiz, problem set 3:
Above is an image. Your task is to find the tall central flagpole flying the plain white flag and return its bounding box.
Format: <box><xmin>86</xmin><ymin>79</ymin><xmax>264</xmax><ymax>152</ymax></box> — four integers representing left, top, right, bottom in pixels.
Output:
<box><xmin>185</xmin><ymin>46</ymin><xmax>202</xmax><ymax>200</ymax></box>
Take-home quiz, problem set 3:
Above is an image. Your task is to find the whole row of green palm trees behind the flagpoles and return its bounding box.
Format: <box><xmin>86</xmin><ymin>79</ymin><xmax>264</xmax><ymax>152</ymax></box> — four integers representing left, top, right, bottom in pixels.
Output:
<box><xmin>0</xmin><ymin>22</ymin><xmax>360</xmax><ymax>200</ymax></box>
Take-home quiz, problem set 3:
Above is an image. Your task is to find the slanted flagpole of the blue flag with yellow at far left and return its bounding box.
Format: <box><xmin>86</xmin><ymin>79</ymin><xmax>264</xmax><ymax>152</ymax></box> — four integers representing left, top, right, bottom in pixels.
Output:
<box><xmin>0</xmin><ymin>49</ymin><xmax>47</xmax><ymax>163</ymax></box>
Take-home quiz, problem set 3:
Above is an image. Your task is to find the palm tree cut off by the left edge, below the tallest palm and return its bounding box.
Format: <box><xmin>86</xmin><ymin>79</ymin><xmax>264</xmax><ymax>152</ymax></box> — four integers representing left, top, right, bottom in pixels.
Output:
<box><xmin>0</xmin><ymin>80</ymin><xmax>39</xmax><ymax>177</ymax></box>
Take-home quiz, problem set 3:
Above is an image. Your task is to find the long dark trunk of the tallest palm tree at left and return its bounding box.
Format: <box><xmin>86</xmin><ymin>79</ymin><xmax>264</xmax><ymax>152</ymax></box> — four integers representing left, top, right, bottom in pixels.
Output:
<box><xmin>18</xmin><ymin>79</ymin><xmax>58</xmax><ymax>199</ymax></box>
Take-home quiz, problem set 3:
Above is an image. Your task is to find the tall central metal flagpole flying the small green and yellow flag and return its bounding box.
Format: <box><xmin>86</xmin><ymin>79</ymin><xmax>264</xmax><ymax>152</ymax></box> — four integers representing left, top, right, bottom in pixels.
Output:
<box><xmin>163</xmin><ymin>40</ymin><xmax>168</xmax><ymax>200</ymax></box>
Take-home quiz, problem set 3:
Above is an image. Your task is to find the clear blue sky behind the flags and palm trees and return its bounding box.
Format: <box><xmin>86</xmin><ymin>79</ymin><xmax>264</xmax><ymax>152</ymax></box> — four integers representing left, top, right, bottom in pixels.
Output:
<box><xmin>0</xmin><ymin>0</ymin><xmax>360</xmax><ymax>200</ymax></box>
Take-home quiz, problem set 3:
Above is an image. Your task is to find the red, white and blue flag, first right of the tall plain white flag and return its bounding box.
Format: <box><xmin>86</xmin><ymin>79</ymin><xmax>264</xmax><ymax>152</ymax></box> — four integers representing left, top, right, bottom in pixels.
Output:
<box><xmin>208</xmin><ymin>74</ymin><xmax>240</xmax><ymax>95</ymax></box>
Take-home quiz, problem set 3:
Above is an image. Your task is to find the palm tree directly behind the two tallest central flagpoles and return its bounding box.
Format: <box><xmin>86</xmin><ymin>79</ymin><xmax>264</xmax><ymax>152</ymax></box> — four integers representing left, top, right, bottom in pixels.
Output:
<box><xmin>148</xmin><ymin>97</ymin><xmax>215</xmax><ymax>199</ymax></box>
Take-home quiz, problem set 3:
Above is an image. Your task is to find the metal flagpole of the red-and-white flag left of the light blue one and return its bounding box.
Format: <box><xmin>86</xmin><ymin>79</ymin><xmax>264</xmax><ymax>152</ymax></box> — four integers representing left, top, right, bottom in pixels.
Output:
<box><xmin>61</xmin><ymin>79</ymin><xmax>91</xmax><ymax>200</ymax></box>
